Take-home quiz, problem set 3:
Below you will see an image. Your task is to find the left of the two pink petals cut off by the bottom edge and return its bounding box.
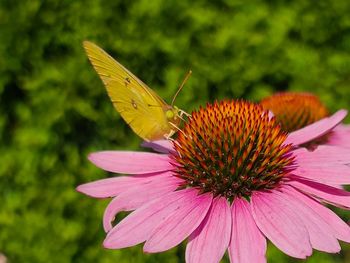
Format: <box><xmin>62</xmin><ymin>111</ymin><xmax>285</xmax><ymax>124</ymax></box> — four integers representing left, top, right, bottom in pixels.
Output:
<box><xmin>186</xmin><ymin>198</ymin><xmax>231</xmax><ymax>263</ymax></box>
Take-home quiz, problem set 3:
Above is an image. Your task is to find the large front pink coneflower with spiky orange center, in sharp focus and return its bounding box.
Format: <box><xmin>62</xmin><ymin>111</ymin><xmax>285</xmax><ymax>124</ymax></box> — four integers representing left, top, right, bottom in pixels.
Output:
<box><xmin>77</xmin><ymin>101</ymin><xmax>350</xmax><ymax>263</ymax></box>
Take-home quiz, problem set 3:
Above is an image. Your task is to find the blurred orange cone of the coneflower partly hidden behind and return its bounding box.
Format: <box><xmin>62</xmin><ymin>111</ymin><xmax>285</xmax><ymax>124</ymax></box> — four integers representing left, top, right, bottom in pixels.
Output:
<box><xmin>260</xmin><ymin>92</ymin><xmax>329</xmax><ymax>132</ymax></box>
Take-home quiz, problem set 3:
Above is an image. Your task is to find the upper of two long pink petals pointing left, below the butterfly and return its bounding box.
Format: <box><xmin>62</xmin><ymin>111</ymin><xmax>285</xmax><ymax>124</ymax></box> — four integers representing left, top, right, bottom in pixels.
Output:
<box><xmin>88</xmin><ymin>151</ymin><xmax>172</xmax><ymax>174</ymax></box>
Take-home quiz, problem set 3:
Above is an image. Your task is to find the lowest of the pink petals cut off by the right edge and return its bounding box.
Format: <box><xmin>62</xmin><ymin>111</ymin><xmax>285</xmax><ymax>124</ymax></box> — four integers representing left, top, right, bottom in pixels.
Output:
<box><xmin>283</xmin><ymin>187</ymin><xmax>350</xmax><ymax>242</ymax></box>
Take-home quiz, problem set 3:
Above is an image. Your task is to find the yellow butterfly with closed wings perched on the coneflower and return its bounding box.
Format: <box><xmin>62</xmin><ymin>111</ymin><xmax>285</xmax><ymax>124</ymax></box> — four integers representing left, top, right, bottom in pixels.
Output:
<box><xmin>83</xmin><ymin>41</ymin><xmax>190</xmax><ymax>141</ymax></box>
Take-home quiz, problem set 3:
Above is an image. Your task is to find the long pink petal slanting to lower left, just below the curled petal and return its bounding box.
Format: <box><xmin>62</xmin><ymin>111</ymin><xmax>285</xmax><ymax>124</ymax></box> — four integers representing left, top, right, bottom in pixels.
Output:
<box><xmin>103</xmin><ymin>189</ymin><xmax>205</xmax><ymax>249</ymax></box>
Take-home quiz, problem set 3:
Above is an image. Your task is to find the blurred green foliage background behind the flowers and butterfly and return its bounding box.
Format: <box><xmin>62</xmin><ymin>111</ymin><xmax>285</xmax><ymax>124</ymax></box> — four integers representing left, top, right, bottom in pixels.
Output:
<box><xmin>0</xmin><ymin>0</ymin><xmax>350</xmax><ymax>263</ymax></box>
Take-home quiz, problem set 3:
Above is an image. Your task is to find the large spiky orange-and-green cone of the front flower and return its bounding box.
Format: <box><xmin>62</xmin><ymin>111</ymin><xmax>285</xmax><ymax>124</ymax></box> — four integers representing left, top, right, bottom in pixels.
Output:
<box><xmin>172</xmin><ymin>101</ymin><xmax>294</xmax><ymax>200</ymax></box>
